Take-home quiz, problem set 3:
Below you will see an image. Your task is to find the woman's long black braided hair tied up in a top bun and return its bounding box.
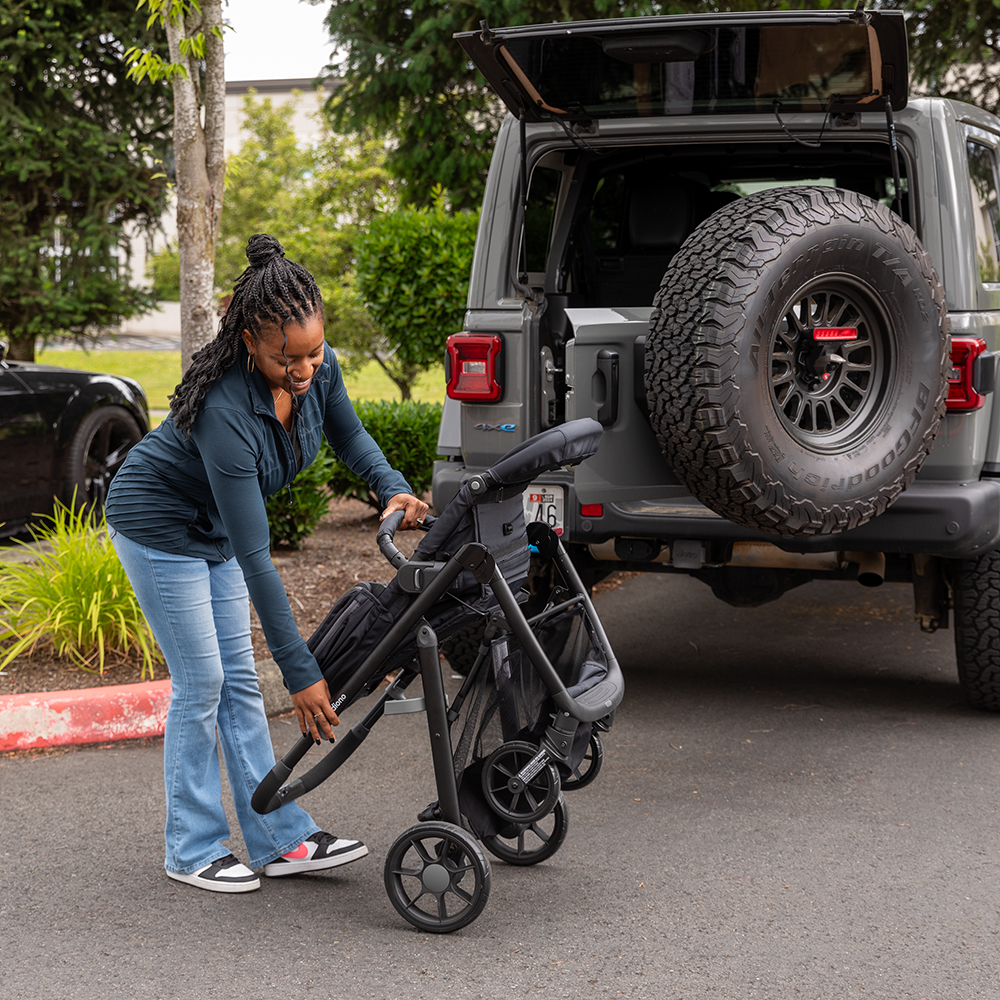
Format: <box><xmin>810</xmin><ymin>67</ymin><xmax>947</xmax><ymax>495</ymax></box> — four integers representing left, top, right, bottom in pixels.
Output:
<box><xmin>170</xmin><ymin>233</ymin><xmax>323</xmax><ymax>438</ymax></box>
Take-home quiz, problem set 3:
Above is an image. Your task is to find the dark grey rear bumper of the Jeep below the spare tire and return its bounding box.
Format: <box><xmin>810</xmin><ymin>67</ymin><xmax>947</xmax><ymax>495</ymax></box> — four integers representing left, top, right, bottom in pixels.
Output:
<box><xmin>434</xmin><ymin>462</ymin><xmax>1000</xmax><ymax>559</ymax></box>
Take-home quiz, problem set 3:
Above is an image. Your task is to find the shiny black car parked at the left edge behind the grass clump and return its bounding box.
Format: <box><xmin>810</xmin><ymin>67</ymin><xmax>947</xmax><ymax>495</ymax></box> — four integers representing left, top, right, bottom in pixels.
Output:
<box><xmin>0</xmin><ymin>344</ymin><xmax>149</xmax><ymax>535</ymax></box>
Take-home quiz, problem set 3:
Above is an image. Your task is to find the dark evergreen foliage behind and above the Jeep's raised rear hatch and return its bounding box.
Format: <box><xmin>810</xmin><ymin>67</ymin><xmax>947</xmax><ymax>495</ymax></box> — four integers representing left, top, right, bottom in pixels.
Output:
<box><xmin>311</xmin><ymin>0</ymin><xmax>1000</xmax><ymax>208</ymax></box>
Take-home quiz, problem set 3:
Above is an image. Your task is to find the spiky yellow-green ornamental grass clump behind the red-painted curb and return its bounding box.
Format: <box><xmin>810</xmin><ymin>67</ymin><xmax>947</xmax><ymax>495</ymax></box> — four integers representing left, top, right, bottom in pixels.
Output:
<box><xmin>0</xmin><ymin>502</ymin><xmax>163</xmax><ymax>679</ymax></box>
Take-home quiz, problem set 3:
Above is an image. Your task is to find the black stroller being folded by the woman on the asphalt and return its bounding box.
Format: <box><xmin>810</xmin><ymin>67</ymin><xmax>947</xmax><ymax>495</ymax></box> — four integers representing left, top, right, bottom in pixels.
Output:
<box><xmin>253</xmin><ymin>419</ymin><xmax>624</xmax><ymax>933</ymax></box>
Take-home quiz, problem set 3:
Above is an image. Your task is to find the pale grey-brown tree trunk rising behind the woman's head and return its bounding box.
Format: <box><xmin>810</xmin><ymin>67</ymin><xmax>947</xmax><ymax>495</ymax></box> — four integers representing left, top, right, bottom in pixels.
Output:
<box><xmin>166</xmin><ymin>0</ymin><xmax>226</xmax><ymax>372</ymax></box>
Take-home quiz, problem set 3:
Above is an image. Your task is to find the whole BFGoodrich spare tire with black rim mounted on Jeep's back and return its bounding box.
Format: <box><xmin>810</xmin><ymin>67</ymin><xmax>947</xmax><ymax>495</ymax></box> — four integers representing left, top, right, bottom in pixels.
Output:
<box><xmin>645</xmin><ymin>187</ymin><xmax>949</xmax><ymax>535</ymax></box>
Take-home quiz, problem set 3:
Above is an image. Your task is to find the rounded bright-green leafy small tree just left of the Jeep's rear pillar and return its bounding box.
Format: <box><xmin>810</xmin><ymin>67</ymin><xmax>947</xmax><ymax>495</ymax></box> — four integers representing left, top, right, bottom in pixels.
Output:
<box><xmin>357</xmin><ymin>187</ymin><xmax>479</xmax><ymax>400</ymax></box>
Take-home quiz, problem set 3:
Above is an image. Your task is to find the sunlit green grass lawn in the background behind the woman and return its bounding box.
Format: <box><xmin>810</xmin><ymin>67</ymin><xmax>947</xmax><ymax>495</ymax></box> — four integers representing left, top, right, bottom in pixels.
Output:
<box><xmin>36</xmin><ymin>351</ymin><xmax>444</xmax><ymax>414</ymax></box>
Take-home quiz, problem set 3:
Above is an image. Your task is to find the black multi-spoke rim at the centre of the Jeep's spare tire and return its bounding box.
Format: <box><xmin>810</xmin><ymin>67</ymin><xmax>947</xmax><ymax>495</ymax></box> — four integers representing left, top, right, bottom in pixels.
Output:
<box><xmin>767</xmin><ymin>275</ymin><xmax>897</xmax><ymax>452</ymax></box>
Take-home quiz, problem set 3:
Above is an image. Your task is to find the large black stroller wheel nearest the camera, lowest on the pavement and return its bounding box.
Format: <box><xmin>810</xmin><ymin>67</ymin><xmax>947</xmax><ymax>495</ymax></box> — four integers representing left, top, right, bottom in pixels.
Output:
<box><xmin>385</xmin><ymin>822</ymin><xmax>490</xmax><ymax>934</ymax></box>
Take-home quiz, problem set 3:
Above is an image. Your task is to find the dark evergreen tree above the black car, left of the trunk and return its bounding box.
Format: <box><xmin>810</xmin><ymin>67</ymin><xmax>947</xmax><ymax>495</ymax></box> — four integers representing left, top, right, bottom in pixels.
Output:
<box><xmin>0</xmin><ymin>0</ymin><xmax>170</xmax><ymax>360</ymax></box>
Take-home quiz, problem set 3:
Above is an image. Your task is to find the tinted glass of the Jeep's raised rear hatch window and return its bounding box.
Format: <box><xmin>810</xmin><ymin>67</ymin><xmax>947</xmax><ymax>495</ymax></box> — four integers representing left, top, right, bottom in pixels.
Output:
<box><xmin>503</xmin><ymin>24</ymin><xmax>875</xmax><ymax>117</ymax></box>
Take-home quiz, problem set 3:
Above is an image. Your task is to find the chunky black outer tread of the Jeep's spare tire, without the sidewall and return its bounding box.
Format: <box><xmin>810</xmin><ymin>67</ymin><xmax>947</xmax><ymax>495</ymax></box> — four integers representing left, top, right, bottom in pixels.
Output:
<box><xmin>645</xmin><ymin>188</ymin><xmax>948</xmax><ymax>535</ymax></box>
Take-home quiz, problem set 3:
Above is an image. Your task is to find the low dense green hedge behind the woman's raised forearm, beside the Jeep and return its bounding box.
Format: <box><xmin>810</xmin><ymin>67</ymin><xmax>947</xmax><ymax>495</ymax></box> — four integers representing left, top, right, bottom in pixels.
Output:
<box><xmin>329</xmin><ymin>400</ymin><xmax>442</xmax><ymax>510</ymax></box>
